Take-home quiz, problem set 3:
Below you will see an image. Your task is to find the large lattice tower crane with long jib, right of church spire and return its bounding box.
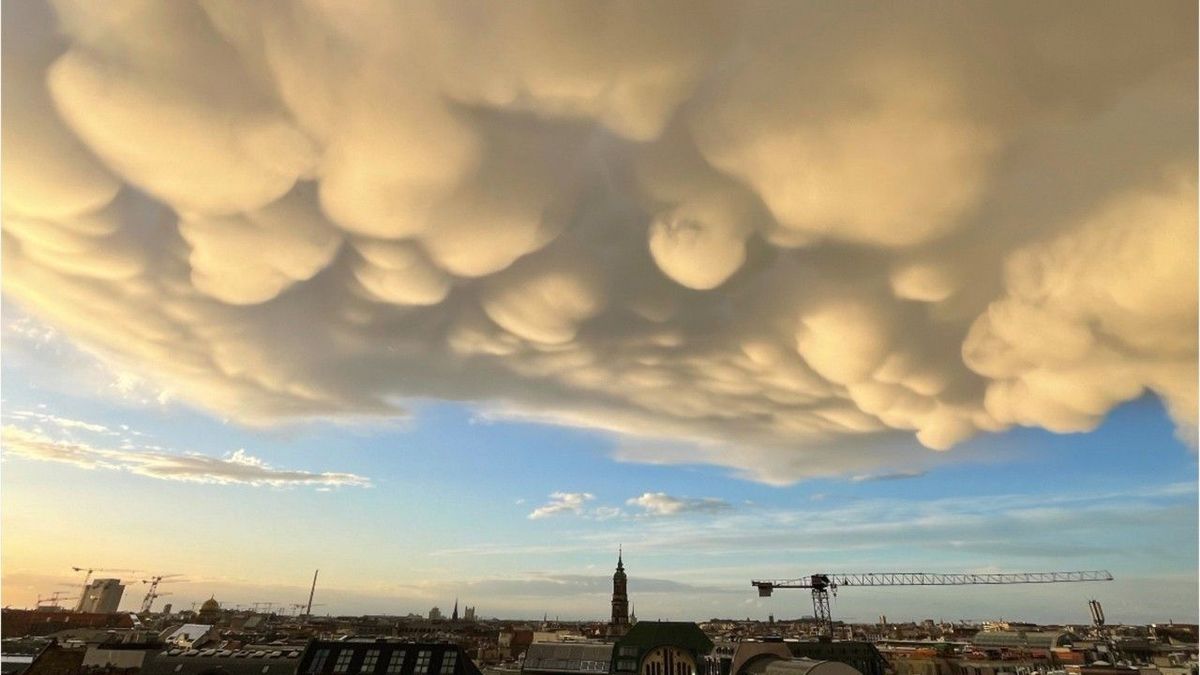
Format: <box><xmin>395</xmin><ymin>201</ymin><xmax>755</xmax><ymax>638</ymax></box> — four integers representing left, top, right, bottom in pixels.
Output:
<box><xmin>750</xmin><ymin>569</ymin><xmax>1112</xmax><ymax>637</ymax></box>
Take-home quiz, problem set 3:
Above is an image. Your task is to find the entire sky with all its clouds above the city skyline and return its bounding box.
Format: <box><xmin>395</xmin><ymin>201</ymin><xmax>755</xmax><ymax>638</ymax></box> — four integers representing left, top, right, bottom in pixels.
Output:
<box><xmin>0</xmin><ymin>0</ymin><xmax>1200</xmax><ymax>622</ymax></box>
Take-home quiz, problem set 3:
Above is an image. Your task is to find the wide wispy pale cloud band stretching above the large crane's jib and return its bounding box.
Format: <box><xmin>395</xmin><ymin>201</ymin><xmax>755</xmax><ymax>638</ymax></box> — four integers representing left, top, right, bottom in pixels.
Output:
<box><xmin>446</xmin><ymin>483</ymin><xmax>1196</xmax><ymax>564</ymax></box>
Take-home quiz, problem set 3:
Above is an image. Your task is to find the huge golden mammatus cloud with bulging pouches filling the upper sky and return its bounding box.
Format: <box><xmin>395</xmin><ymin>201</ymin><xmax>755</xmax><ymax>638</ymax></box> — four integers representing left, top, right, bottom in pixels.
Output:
<box><xmin>2</xmin><ymin>0</ymin><xmax>1198</xmax><ymax>483</ymax></box>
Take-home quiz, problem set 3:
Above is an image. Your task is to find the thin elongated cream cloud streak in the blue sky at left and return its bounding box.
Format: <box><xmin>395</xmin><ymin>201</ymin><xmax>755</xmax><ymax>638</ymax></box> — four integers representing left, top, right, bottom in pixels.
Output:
<box><xmin>2</xmin><ymin>425</ymin><xmax>371</xmax><ymax>489</ymax></box>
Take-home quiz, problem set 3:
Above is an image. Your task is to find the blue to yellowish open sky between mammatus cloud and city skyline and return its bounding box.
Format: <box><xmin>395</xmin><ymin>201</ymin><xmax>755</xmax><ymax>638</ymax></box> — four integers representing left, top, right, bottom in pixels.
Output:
<box><xmin>4</xmin><ymin>305</ymin><xmax>1196</xmax><ymax>621</ymax></box>
